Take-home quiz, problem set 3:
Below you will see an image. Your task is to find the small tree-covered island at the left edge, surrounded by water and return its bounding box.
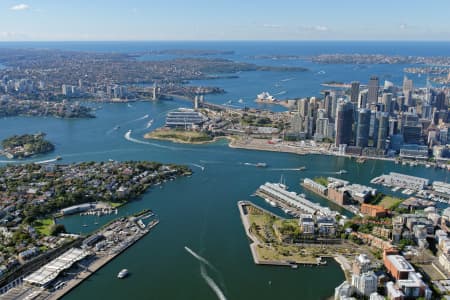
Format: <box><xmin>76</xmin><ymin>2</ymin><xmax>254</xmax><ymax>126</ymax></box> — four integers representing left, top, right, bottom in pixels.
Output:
<box><xmin>0</xmin><ymin>133</ymin><xmax>55</xmax><ymax>159</ymax></box>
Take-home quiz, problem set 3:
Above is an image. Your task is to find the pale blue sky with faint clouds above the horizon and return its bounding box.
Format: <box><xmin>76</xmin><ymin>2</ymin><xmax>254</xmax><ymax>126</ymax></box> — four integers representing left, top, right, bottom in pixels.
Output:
<box><xmin>0</xmin><ymin>0</ymin><xmax>450</xmax><ymax>41</ymax></box>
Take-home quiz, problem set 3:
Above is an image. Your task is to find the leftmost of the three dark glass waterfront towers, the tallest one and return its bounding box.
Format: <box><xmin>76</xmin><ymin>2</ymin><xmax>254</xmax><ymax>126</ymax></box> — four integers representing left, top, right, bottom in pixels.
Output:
<box><xmin>335</xmin><ymin>101</ymin><xmax>353</xmax><ymax>146</ymax></box>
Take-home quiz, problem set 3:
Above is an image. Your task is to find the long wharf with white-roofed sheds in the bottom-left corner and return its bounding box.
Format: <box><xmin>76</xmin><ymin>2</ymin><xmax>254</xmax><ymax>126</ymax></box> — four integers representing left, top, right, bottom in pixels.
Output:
<box><xmin>2</xmin><ymin>211</ymin><xmax>159</xmax><ymax>300</ymax></box>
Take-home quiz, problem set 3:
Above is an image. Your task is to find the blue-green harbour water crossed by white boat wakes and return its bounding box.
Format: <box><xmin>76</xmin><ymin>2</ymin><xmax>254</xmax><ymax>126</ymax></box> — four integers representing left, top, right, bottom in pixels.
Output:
<box><xmin>0</xmin><ymin>43</ymin><xmax>448</xmax><ymax>299</ymax></box>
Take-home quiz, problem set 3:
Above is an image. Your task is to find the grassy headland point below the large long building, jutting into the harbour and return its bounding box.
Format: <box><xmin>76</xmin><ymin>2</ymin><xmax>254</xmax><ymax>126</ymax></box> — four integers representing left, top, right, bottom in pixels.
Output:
<box><xmin>144</xmin><ymin>128</ymin><xmax>213</xmax><ymax>143</ymax></box>
